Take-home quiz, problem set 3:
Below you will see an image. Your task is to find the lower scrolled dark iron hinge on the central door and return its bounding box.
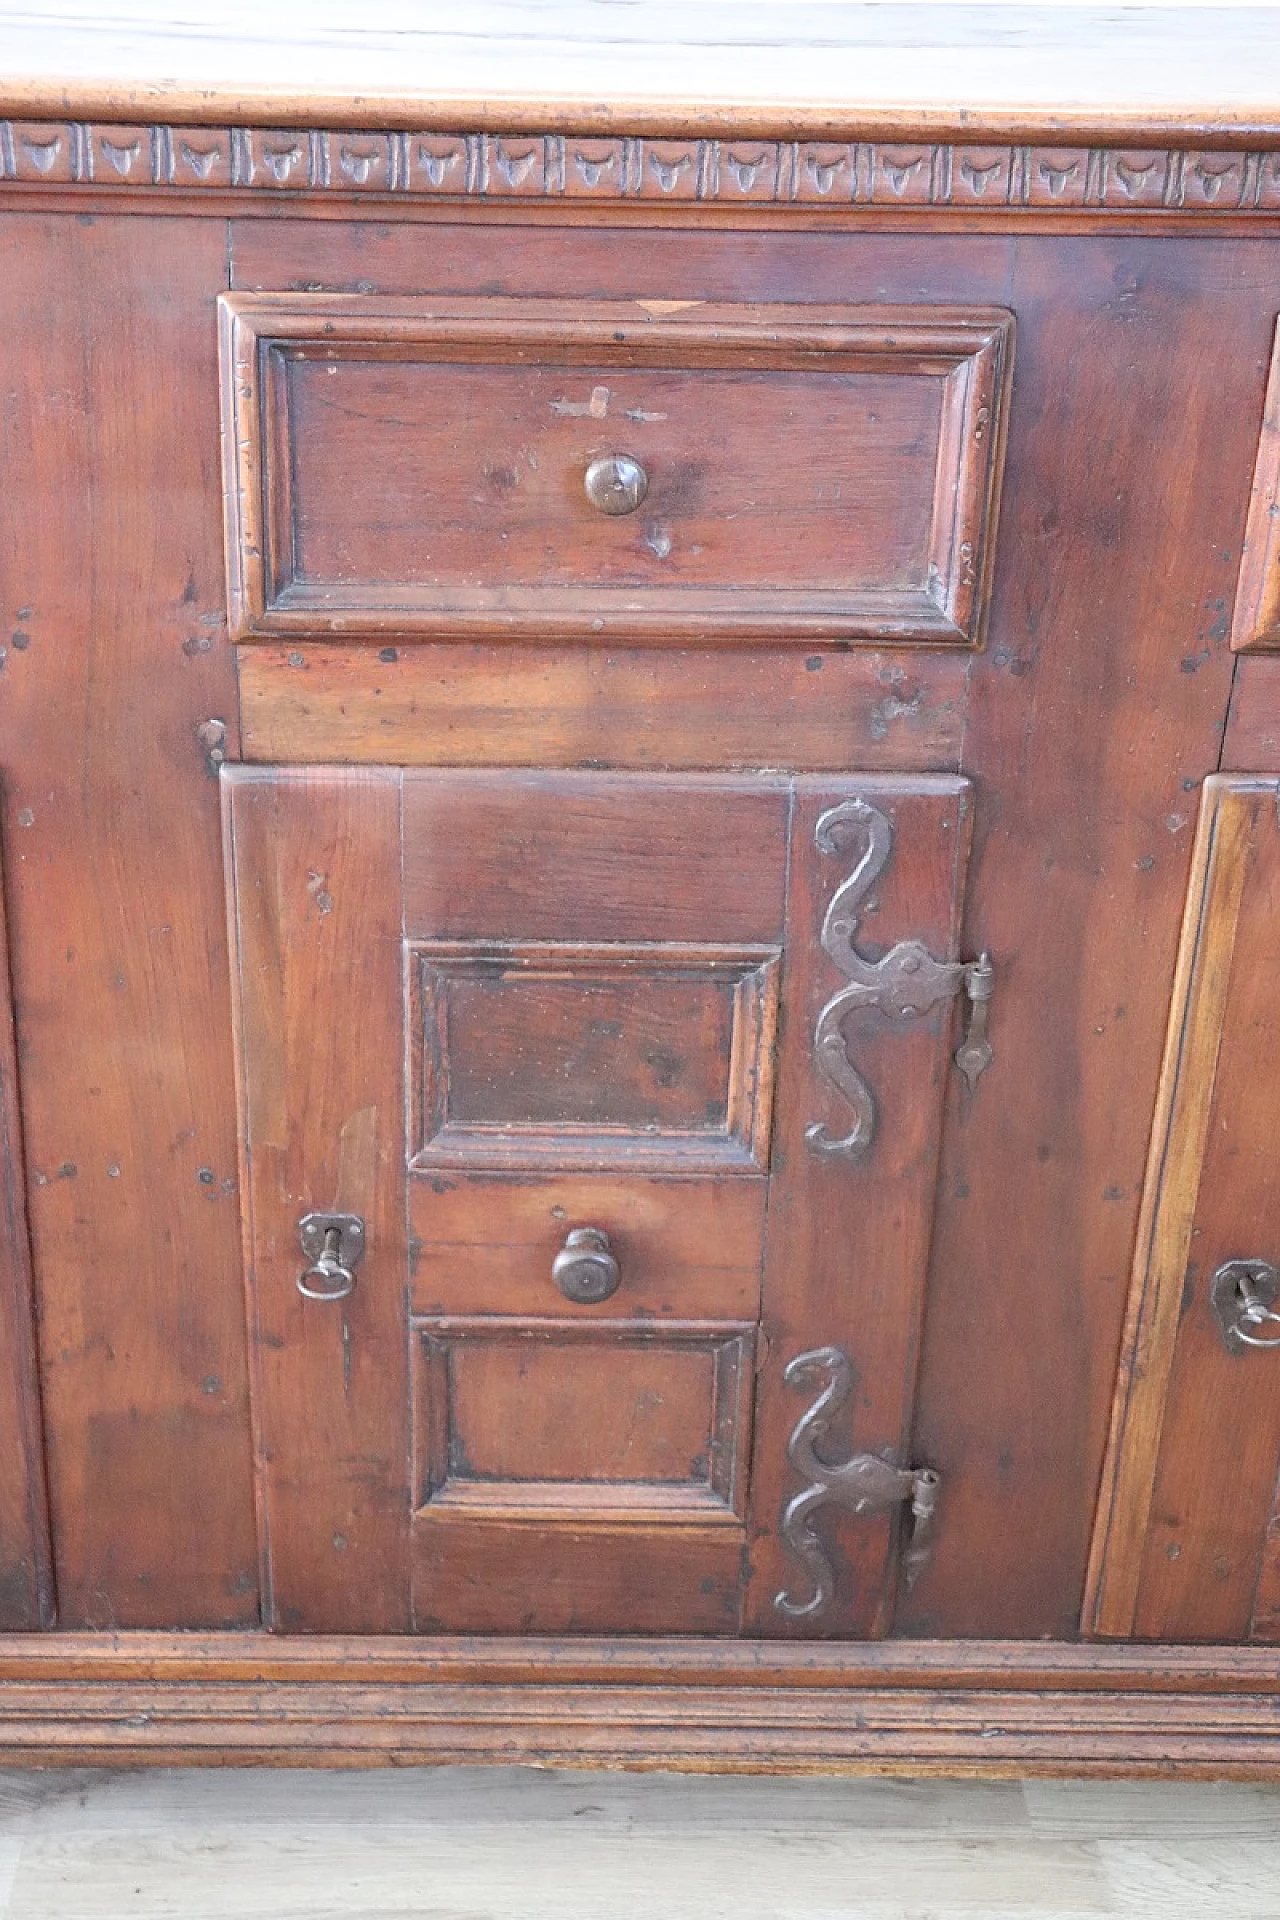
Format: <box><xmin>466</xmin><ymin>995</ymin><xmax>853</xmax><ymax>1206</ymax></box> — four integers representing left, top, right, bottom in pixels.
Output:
<box><xmin>773</xmin><ymin>1346</ymin><xmax>940</xmax><ymax>1620</ymax></box>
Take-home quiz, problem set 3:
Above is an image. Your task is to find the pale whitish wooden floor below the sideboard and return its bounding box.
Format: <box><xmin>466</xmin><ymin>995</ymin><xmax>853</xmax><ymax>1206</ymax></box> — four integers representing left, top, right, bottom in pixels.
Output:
<box><xmin>0</xmin><ymin>1768</ymin><xmax>1280</xmax><ymax>1920</ymax></box>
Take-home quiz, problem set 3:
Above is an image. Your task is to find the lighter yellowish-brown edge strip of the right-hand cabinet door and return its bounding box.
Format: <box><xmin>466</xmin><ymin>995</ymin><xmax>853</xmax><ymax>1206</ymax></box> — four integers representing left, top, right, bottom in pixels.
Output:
<box><xmin>1084</xmin><ymin>778</ymin><xmax>1276</xmax><ymax>1638</ymax></box>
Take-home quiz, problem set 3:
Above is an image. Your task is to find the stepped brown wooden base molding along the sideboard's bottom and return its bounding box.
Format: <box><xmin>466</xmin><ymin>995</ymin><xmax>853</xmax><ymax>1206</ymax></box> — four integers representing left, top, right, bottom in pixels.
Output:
<box><xmin>0</xmin><ymin>1632</ymin><xmax>1280</xmax><ymax>1778</ymax></box>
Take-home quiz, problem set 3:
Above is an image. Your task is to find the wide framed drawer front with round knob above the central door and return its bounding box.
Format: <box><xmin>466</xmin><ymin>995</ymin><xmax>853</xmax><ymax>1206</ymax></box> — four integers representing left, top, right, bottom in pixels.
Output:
<box><xmin>223</xmin><ymin>294</ymin><xmax>1013</xmax><ymax>643</ymax></box>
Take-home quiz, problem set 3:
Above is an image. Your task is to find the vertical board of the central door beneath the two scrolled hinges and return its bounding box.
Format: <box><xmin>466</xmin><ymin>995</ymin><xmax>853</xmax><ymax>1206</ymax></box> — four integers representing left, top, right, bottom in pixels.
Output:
<box><xmin>747</xmin><ymin>776</ymin><xmax>971</xmax><ymax>1636</ymax></box>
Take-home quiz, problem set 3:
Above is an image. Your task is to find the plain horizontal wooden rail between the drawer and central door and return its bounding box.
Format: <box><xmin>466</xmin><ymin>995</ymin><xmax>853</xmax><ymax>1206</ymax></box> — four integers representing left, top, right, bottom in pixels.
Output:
<box><xmin>240</xmin><ymin>641</ymin><xmax>969</xmax><ymax>772</ymax></box>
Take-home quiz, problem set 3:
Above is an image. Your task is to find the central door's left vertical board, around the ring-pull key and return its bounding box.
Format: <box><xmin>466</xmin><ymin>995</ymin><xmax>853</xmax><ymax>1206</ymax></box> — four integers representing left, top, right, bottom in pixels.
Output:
<box><xmin>223</xmin><ymin>768</ymin><xmax>409</xmax><ymax>1632</ymax></box>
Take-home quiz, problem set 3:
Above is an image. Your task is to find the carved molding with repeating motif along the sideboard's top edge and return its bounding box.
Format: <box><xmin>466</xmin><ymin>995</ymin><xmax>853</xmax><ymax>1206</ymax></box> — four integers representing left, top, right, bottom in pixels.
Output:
<box><xmin>0</xmin><ymin>121</ymin><xmax>1280</xmax><ymax>217</ymax></box>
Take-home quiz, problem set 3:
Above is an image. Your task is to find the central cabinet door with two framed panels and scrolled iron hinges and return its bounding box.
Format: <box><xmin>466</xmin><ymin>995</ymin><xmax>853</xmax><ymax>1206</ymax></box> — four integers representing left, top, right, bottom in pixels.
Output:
<box><xmin>225</xmin><ymin>768</ymin><xmax>974</xmax><ymax>1634</ymax></box>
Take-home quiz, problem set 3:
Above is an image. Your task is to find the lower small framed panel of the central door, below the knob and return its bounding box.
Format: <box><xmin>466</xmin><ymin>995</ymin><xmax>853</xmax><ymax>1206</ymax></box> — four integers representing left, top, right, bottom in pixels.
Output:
<box><xmin>413</xmin><ymin>1319</ymin><xmax>752</xmax><ymax>1526</ymax></box>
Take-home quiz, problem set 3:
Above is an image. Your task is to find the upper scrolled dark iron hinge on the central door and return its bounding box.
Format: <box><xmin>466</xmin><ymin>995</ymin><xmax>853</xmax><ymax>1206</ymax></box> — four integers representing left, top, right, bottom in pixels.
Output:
<box><xmin>804</xmin><ymin>799</ymin><xmax>996</xmax><ymax>1158</ymax></box>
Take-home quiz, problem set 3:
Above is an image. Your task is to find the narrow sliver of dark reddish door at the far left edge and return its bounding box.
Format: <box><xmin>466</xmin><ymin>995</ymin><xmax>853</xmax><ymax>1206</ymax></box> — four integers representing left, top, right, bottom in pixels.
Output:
<box><xmin>0</xmin><ymin>840</ymin><xmax>54</xmax><ymax>1630</ymax></box>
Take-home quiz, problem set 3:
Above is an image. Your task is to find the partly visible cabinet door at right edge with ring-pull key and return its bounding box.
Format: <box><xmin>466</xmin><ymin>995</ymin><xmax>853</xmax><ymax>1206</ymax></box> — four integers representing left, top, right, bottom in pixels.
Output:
<box><xmin>1084</xmin><ymin>774</ymin><xmax>1280</xmax><ymax>1640</ymax></box>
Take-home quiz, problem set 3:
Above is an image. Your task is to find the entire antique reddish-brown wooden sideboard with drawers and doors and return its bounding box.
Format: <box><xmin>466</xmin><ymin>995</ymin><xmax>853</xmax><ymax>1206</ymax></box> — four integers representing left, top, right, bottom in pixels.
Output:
<box><xmin>0</xmin><ymin>4</ymin><xmax>1280</xmax><ymax>1774</ymax></box>
